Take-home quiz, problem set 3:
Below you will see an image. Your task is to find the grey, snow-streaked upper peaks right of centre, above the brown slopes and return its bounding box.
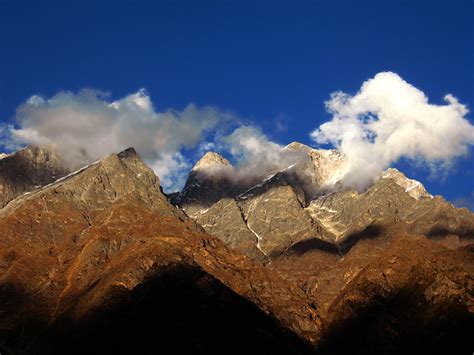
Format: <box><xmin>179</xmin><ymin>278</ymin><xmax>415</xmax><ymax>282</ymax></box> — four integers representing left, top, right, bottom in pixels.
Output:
<box><xmin>176</xmin><ymin>142</ymin><xmax>474</xmax><ymax>259</ymax></box>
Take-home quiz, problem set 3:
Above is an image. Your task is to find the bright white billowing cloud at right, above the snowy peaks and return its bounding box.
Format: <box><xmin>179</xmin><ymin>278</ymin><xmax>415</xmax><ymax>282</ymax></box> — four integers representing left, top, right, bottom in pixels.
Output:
<box><xmin>311</xmin><ymin>72</ymin><xmax>474</xmax><ymax>189</ymax></box>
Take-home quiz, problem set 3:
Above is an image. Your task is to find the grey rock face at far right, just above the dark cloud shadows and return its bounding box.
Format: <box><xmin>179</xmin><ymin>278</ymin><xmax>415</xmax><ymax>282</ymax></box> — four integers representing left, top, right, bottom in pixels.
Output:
<box><xmin>306</xmin><ymin>172</ymin><xmax>474</xmax><ymax>246</ymax></box>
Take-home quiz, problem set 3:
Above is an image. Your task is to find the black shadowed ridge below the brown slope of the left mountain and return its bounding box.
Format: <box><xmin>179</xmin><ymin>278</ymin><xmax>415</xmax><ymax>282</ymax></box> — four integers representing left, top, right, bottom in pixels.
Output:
<box><xmin>2</xmin><ymin>265</ymin><xmax>311</xmax><ymax>354</ymax></box>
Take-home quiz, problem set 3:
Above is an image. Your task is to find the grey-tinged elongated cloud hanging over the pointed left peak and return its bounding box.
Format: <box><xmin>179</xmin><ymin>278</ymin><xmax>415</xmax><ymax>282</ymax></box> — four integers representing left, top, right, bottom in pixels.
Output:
<box><xmin>6</xmin><ymin>90</ymin><xmax>232</xmax><ymax>191</ymax></box>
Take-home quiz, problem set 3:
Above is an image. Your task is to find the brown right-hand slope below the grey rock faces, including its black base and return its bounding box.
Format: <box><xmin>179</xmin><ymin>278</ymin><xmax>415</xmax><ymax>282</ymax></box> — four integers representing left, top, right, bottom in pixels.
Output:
<box><xmin>268</xmin><ymin>227</ymin><xmax>474</xmax><ymax>354</ymax></box>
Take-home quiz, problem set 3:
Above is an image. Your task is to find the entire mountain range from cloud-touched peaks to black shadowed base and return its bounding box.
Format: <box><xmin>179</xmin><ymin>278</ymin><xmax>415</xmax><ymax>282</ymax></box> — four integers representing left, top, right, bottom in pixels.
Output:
<box><xmin>0</xmin><ymin>142</ymin><xmax>474</xmax><ymax>354</ymax></box>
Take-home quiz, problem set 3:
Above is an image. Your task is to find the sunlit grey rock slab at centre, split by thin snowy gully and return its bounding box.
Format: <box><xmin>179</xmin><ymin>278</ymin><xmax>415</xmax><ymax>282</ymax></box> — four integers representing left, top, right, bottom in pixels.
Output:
<box><xmin>190</xmin><ymin>185</ymin><xmax>314</xmax><ymax>259</ymax></box>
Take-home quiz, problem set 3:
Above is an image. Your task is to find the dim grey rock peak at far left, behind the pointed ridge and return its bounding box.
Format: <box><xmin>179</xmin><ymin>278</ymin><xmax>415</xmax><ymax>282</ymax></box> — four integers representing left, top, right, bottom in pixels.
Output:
<box><xmin>0</xmin><ymin>146</ymin><xmax>70</xmax><ymax>208</ymax></box>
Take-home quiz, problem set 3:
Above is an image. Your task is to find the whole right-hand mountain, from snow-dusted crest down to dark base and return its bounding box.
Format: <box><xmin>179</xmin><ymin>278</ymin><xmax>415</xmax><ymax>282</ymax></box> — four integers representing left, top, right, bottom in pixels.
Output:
<box><xmin>172</xmin><ymin>143</ymin><xmax>474</xmax><ymax>354</ymax></box>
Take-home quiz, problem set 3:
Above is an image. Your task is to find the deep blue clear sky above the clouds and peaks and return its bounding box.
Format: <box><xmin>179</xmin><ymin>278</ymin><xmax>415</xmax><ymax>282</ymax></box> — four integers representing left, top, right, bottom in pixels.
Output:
<box><xmin>0</xmin><ymin>0</ymin><xmax>474</xmax><ymax>207</ymax></box>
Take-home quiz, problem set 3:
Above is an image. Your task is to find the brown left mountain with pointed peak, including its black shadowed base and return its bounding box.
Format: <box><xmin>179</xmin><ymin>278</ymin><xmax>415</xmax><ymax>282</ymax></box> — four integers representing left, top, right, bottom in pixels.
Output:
<box><xmin>0</xmin><ymin>150</ymin><xmax>320</xmax><ymax>353</ymax></box>
